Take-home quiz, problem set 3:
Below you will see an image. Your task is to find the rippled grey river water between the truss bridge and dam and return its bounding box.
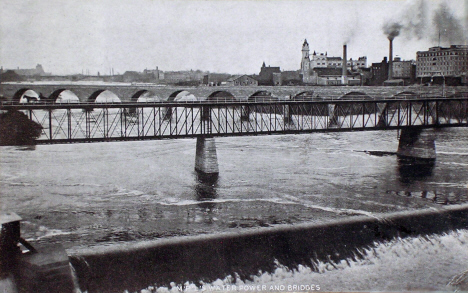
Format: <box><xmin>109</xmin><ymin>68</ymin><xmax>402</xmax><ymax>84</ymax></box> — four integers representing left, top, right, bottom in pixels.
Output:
<box><xmin>0</xmin><ymin>128</ymin><xmax>468</xmax><ymax>290</ymax></box>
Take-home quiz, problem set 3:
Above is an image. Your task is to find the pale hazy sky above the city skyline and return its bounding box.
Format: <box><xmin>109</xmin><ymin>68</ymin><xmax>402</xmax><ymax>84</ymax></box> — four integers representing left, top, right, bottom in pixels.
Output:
<box><xmin>0</xmin><ymin>0</ymin><xmax>468</xmax><ymax>74</ymax></box>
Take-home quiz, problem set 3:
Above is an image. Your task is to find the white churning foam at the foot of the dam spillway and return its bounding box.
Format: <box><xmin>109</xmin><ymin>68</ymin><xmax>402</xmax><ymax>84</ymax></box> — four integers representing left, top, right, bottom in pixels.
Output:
<box><xmin>140</xmin><ymin>230</ymin><xmax>468</xmax><ymax>293</ymax></box>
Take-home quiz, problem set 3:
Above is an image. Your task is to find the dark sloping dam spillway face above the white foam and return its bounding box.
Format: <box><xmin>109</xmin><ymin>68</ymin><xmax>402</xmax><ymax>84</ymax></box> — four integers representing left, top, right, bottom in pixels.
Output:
<box><xmin>70</xmin><ymin>204</ymin><xmax>468</xmax><ymax>292</ymax></box>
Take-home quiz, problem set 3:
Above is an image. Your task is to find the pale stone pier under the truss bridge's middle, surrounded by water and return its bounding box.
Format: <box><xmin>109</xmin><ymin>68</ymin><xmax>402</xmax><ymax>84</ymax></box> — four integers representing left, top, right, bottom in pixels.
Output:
<box><xmin>195</xmin><ymin>137</ymin><xmax>219</xmax><ymax>177</ymax></box>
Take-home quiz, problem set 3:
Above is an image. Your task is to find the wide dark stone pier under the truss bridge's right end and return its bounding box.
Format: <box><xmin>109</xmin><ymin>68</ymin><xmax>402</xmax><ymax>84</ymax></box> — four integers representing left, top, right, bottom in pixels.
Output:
<box><xmin>397</xmin><ymin>128</ymin><xmax>436</xmax><ymax>160</ymax></box>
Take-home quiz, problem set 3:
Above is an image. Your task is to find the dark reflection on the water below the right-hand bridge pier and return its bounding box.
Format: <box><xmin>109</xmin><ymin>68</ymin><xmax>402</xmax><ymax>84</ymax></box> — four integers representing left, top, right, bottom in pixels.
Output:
<box><xmin>397</xmin><ymin>157</ymin><xmax>435</xmax><ymax>184</ymax></box>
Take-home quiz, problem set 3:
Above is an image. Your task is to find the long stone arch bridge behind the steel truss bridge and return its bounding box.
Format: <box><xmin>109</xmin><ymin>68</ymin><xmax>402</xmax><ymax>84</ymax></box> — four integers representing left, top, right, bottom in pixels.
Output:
<box><xmin>0</xmin><ymin>82</ymin><xmax>458</xmax><ymax>103</ymax></box>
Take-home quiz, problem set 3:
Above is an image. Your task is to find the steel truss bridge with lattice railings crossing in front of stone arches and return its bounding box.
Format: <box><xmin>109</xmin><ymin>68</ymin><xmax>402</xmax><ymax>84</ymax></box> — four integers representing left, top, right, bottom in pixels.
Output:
<box><xmin>0</xmin><ymin>98</ymin><xmax>468</xmax><ymax>144</ymax></box>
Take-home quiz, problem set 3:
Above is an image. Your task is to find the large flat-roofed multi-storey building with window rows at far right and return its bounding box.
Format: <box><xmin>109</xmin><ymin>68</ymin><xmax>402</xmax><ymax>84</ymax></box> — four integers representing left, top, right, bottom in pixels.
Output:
<box><xmin>416</xmin><ymin>45</ymin><xmax>468</xmax><ymax>83</ymax></box>
